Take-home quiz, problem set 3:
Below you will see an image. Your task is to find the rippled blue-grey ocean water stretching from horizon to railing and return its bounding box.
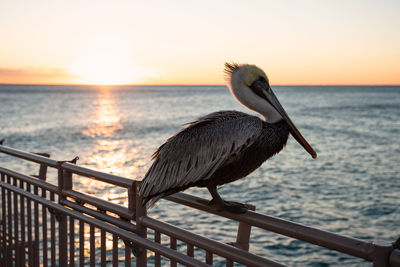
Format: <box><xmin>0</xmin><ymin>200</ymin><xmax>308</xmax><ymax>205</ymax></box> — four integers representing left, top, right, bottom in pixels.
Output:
<box><xmin>0</xmin><ymin>85</ymin><xmax>400</xmax><ymax>266</ymax></box>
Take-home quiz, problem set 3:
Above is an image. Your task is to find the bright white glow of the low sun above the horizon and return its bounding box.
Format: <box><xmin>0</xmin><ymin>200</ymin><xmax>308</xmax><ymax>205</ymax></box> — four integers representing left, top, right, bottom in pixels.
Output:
<box><xmin>69</xmin><ymin>51</ymin><xmax>144</xmax><ymax>85</ymax></box>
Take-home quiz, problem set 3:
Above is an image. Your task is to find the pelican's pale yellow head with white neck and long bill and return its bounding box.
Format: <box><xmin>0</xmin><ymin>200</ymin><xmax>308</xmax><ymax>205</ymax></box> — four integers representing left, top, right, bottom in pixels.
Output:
<box><xmin>225</xmin><ymin>63</ymin><xmax>317</xmax><ymax>159</ymax></box>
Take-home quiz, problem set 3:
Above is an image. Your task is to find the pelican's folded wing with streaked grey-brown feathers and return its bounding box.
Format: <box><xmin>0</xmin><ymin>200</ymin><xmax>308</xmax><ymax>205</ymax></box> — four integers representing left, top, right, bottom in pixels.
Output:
<box><xmin>140</xmin><ymin>111</ymin><xmax>262</xmax><ymax>203</ymax></box>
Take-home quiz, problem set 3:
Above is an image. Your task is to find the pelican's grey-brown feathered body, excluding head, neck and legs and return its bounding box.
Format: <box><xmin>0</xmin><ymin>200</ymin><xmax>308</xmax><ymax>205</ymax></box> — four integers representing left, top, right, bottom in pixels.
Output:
<box><xmin>140</xmin><ymin>111</ymin><xmax>289</xmax><ymax>207</ymax></box>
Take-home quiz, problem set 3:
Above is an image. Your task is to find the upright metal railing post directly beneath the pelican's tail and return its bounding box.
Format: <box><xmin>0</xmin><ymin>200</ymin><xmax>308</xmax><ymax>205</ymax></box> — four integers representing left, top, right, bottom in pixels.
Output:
<box><xmin>135</xmin><ymin>183</ymin><xmax>147</xmax><ymax>267</ymax></box>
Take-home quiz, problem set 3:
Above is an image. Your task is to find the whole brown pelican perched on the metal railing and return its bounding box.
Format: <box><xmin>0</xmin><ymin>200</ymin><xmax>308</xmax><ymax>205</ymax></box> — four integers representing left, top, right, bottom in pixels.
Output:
<box><xmin>139</xmin><ymin>63</ymin><xmax>317</xmax><ymax>213</ymax></box>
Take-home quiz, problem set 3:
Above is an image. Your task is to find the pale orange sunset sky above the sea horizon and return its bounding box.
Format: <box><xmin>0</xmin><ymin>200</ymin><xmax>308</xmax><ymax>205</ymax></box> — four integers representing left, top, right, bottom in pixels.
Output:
<box><xmin>0</xmin><ymin>0</ymin><xmax>400</xmax><ymax>85</ymax></box>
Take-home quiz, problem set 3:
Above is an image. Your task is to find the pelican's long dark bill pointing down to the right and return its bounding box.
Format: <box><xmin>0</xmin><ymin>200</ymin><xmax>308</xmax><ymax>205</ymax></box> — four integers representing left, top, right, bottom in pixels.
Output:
<box><xmin>253</xmin><ymin>81</ymin><xmax>317</xmax><ymax>159</ymax></box>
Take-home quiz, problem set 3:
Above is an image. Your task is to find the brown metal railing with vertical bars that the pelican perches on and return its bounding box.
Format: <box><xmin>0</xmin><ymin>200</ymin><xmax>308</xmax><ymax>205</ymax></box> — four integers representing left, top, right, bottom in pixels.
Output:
<box><xmin>0</xmin><ymin>145</ymin><xmax>400</xmax><ymax>267</ymax></box>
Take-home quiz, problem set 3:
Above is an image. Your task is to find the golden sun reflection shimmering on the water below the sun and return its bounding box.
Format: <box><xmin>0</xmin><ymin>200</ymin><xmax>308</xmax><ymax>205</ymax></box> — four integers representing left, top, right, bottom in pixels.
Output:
<box><xmin>79</xmin><ymin>87</ymin><xmax>145</xmax><ymax>206</ymax></box>
